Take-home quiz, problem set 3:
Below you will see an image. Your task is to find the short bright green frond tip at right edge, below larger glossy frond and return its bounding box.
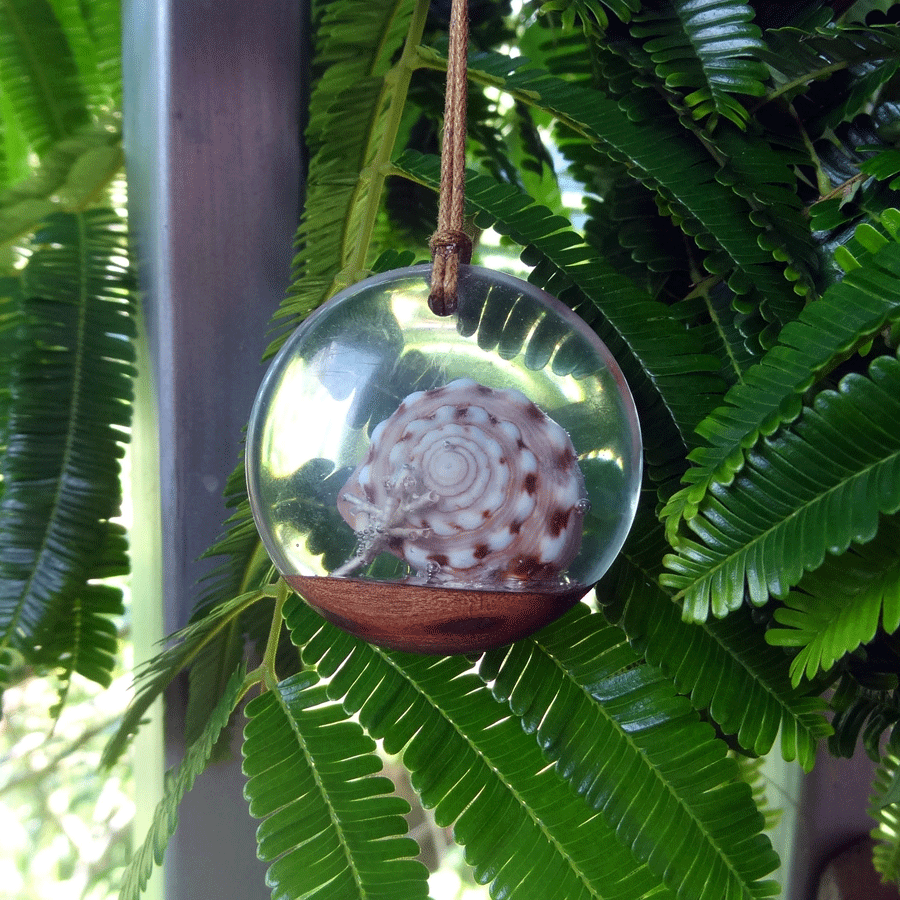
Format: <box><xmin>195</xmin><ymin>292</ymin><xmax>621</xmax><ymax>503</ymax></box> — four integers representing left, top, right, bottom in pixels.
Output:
<box><xmin>766</xmin><ymin>518</ymin><xmax>900</xmax><ymax>687</ymax></box>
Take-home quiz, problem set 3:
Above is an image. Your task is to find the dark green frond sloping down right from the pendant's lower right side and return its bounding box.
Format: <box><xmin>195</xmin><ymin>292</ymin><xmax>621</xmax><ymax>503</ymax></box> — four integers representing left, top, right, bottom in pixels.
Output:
<box><xmin>597</xmin><ymin>510</ymin><xmax>831</xmax><ymax>771</ymax></box>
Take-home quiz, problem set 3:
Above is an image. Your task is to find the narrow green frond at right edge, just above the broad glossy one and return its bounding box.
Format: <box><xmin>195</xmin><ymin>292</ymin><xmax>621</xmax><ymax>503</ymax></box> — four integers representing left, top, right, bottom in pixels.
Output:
<box><xmin>663</xmin><ymin>216</ymin><xmax>900</xmax><ymax>545</ymax></box>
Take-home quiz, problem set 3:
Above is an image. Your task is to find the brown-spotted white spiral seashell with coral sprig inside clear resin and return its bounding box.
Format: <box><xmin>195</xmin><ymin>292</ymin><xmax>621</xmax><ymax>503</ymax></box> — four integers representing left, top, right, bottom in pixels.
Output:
<box><xmin>332</xmin><ymin>378</ymin><xmax>589</xmax><ymax>590</ymax></box>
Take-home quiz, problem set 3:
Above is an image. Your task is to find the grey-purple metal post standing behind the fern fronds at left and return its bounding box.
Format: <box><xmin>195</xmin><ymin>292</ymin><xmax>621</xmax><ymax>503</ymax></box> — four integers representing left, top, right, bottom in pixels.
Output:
<box><xmin>123</xmin><ymin>0</ymin><xmax>303</xmax><ymax>900</ymax></box>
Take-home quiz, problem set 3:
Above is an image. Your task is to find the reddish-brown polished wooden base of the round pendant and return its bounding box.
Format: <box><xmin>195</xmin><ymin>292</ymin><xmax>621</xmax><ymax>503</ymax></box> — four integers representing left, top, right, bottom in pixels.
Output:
<box><xmin>285</xmin><ymin>575</ymin><xmax>590</xmax><ymax>655</ymax></box>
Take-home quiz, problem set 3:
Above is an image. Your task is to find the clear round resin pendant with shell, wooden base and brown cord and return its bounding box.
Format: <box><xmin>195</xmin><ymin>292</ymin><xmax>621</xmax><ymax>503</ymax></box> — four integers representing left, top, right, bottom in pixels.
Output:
<box><xmin>246</xmin><ymin>0</ymin><xmax>641</xmax><ymax>653</ymax></box>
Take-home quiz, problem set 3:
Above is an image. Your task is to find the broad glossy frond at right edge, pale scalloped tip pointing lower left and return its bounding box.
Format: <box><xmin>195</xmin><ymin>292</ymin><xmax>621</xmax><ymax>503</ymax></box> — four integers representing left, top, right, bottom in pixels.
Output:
<box><xmin>662</xmin><ymin>357</ymin><xmax>900</xmax><ymax>621</ymax></box>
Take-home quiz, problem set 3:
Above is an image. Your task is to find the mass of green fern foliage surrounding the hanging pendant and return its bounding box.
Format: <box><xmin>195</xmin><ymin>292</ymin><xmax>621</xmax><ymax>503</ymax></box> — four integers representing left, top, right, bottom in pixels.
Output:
<box><xmin>0</xmin><ymin>0</ymin><xmax>900</xmax><ymax>900</ymax></box>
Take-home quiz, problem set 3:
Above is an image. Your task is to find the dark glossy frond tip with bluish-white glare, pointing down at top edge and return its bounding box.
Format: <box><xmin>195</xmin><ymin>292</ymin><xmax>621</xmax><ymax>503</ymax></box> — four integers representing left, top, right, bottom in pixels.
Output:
<box><xmin>631</xmin><ymin>0</ymin><xmax>768</xmax><ymax>128</ymax></box>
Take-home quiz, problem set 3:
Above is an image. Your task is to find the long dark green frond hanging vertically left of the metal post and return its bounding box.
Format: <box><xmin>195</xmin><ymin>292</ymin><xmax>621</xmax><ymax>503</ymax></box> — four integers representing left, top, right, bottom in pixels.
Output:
<box><xmin>0</xmin><ymin>210</ymin><xmax>134</xmax><ymax>688</ymax></box>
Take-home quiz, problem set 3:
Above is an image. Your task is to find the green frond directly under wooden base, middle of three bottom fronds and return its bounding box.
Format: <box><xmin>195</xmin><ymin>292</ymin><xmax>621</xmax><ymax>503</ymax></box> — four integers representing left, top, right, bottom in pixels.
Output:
<box><xmin>285</xmin><ymin>598</ymin><xmax>680</xmax><ymax>900</ymax></box>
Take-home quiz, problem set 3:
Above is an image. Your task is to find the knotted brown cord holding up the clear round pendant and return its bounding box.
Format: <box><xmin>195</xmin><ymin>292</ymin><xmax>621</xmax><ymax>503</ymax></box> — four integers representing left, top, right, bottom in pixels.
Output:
<box><xmin>428</xmin><ymin>0</ymin><xmax>472</xmax><ymax>316</ymax></box>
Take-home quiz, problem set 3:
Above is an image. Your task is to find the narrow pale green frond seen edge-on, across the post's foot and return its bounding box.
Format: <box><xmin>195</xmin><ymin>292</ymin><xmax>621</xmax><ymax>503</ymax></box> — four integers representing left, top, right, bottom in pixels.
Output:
<box><xmin>119</xmin><ymin>668</ymin><xmax>244</xmax><ymax>900</ymax></box>
